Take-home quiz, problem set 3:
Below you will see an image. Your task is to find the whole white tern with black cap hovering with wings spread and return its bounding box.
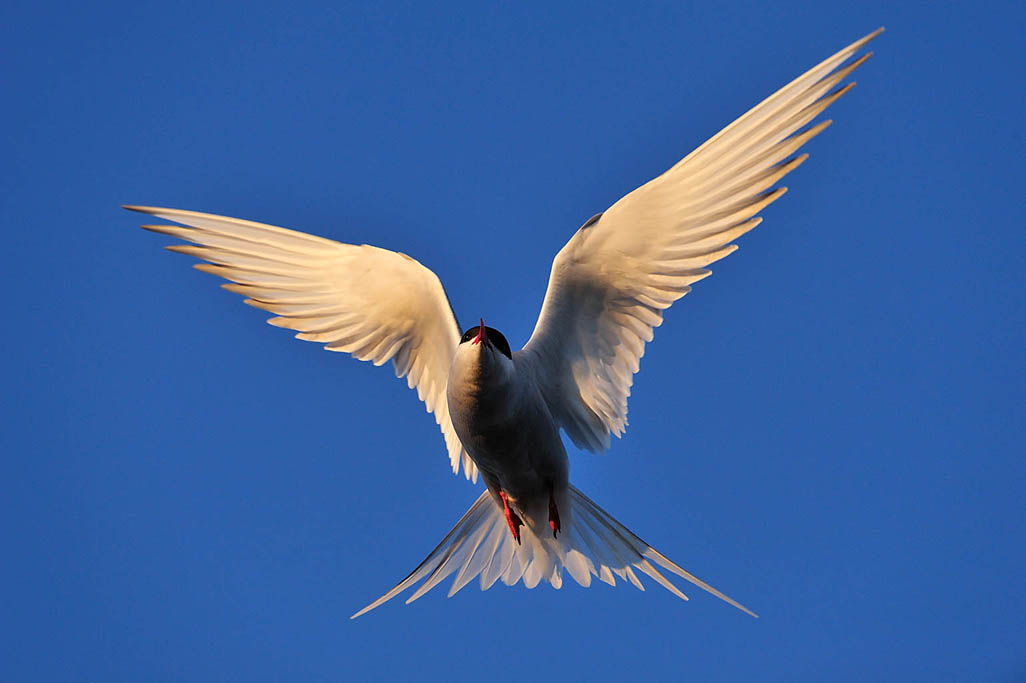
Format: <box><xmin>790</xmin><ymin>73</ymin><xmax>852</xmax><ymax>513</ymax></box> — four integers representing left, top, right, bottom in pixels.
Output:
<box><xmin>125</xmin><ymin>29</ymin><xmax>882</xmax><ymax>618</ymax></box>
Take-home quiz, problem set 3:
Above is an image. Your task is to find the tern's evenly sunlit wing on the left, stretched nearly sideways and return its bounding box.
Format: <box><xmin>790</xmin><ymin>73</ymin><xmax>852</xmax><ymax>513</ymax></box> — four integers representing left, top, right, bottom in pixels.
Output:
<box><xmin>125</xmin><ymin>206</ymin><xmax>477</xmax><ymax>482</ymax></box>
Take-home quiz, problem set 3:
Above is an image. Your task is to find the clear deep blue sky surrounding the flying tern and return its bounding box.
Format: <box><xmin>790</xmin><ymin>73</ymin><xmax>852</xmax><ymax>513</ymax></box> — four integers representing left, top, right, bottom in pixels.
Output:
<box><xmin>0</xmin><ymin>1</ymin><xmax>1026</xmax><ymax>682</ymax></box>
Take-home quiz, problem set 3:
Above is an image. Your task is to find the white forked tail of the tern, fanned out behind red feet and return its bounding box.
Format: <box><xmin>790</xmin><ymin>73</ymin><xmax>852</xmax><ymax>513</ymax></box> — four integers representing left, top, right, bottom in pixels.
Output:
<box><xmin>350</xmin><ymin>486</ymin><xmax>758</xmax><ymax>618</ymax></box>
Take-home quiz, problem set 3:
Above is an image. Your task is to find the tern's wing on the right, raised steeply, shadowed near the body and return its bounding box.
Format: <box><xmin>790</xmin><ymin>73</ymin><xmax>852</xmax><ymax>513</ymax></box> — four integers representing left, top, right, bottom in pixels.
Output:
<box><xmin>521</xmin><ymin>29</ymin><xmax>882</xmax><ymax>451</ymax></box>
